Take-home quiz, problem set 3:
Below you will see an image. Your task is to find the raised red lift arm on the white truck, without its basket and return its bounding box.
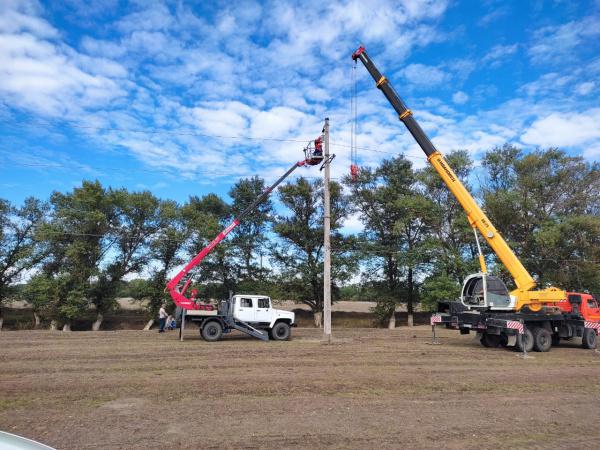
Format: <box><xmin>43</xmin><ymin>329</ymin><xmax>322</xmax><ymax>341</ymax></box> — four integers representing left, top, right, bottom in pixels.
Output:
<box><xmin>167</xmin><ymin>160</ymin><xmax>307</xmax><ymax>310</ymax></box>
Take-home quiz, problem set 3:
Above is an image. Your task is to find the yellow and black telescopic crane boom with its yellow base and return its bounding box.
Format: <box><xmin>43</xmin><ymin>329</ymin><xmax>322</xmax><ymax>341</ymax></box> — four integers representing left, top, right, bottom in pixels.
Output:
<box><xmin>352</xmin><ymin>47</ymin><xmax>566</xmax><ymax>311</ymax></box>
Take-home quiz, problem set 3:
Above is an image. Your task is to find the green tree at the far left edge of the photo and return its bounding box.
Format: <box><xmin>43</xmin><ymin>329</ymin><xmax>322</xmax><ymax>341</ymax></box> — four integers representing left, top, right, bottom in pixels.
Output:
<box><xmin>0</xmin><ymin>197</ymin><xmax>48</xmax><ymax>330</ymax></box>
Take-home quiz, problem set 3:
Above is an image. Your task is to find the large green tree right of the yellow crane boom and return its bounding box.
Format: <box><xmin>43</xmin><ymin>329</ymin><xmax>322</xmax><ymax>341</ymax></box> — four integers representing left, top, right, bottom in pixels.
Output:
<box><xmin>482</xmin><ymin>145</ymin><xmax>600</xmax><ymax>289</ymax></box>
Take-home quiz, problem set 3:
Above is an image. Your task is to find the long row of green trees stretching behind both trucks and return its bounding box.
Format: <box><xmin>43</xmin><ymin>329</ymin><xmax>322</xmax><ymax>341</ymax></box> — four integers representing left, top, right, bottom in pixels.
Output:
<box><xmin>0</xmin><ymin>145</ymin><xmax>600</xmax><ymax>330</ymax></box>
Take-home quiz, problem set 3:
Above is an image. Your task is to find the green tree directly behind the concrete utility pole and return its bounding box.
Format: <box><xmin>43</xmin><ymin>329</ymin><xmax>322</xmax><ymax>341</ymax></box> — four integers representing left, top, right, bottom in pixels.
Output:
<box><xmin>273</xmin><ymin>177</ymin><xmax>356</xmax><ymax>326</ymax></box>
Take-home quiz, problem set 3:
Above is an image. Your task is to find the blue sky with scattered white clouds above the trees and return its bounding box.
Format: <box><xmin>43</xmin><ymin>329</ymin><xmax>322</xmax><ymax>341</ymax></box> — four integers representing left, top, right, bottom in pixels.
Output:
<box><xmin>0</xmin><ymin>0</ymin><xmax>600</xmax><ymax>229</ymax></box>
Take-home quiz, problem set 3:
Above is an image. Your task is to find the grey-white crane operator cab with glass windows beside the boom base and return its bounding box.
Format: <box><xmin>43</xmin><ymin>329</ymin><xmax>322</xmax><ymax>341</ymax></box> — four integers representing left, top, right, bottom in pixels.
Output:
<box><xmin>460</xmin><ymin>273</ymin><xmax>516</xmax><ymax>310</ymax></box>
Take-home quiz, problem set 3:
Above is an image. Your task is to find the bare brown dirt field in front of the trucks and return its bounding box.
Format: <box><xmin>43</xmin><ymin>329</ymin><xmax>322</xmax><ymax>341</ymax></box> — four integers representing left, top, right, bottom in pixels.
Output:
<box><xmin>0</xmin><ymin>326</ymin><xmax>600</xmax><ymax>449</ymax></box>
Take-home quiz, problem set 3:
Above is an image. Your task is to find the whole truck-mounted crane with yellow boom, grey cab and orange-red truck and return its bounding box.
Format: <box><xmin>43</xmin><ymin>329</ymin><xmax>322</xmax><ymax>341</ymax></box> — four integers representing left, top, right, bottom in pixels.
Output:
<box><xmin>352</xmin><ymin>46</ymin><xmax>600</xmax><ymax>351</ymax></box>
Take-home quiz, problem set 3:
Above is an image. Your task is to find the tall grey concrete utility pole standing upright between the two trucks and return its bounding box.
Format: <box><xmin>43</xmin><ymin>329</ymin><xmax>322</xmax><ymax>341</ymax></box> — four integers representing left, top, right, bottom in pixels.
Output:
<box><xmin>323</xmin><ymin>118</ymin><xmax>331</xmax><ymax>343</ymax></box>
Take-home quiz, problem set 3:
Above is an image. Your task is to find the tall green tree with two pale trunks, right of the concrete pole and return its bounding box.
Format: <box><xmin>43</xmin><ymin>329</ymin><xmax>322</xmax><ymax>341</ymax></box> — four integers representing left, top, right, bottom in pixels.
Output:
<box><xmin>349</xmin><ymin>156</ymin><xmax>434</xmax><ymax>328</ymax></box>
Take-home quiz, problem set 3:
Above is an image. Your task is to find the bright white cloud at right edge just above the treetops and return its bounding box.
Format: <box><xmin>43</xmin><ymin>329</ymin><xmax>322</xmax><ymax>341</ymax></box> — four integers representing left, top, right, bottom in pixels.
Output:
<box><xmin>521</xmin><ymin>108</ymin><xmax>600</xmax><ymax>147</ymax></box>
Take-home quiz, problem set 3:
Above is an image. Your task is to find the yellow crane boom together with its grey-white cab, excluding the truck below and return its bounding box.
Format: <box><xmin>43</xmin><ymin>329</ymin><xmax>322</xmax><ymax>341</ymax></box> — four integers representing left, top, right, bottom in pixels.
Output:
<box><xmin>352</xmin><ymin>47</ymin><xmax>567</xmax><ymax>312</ymax></box>
